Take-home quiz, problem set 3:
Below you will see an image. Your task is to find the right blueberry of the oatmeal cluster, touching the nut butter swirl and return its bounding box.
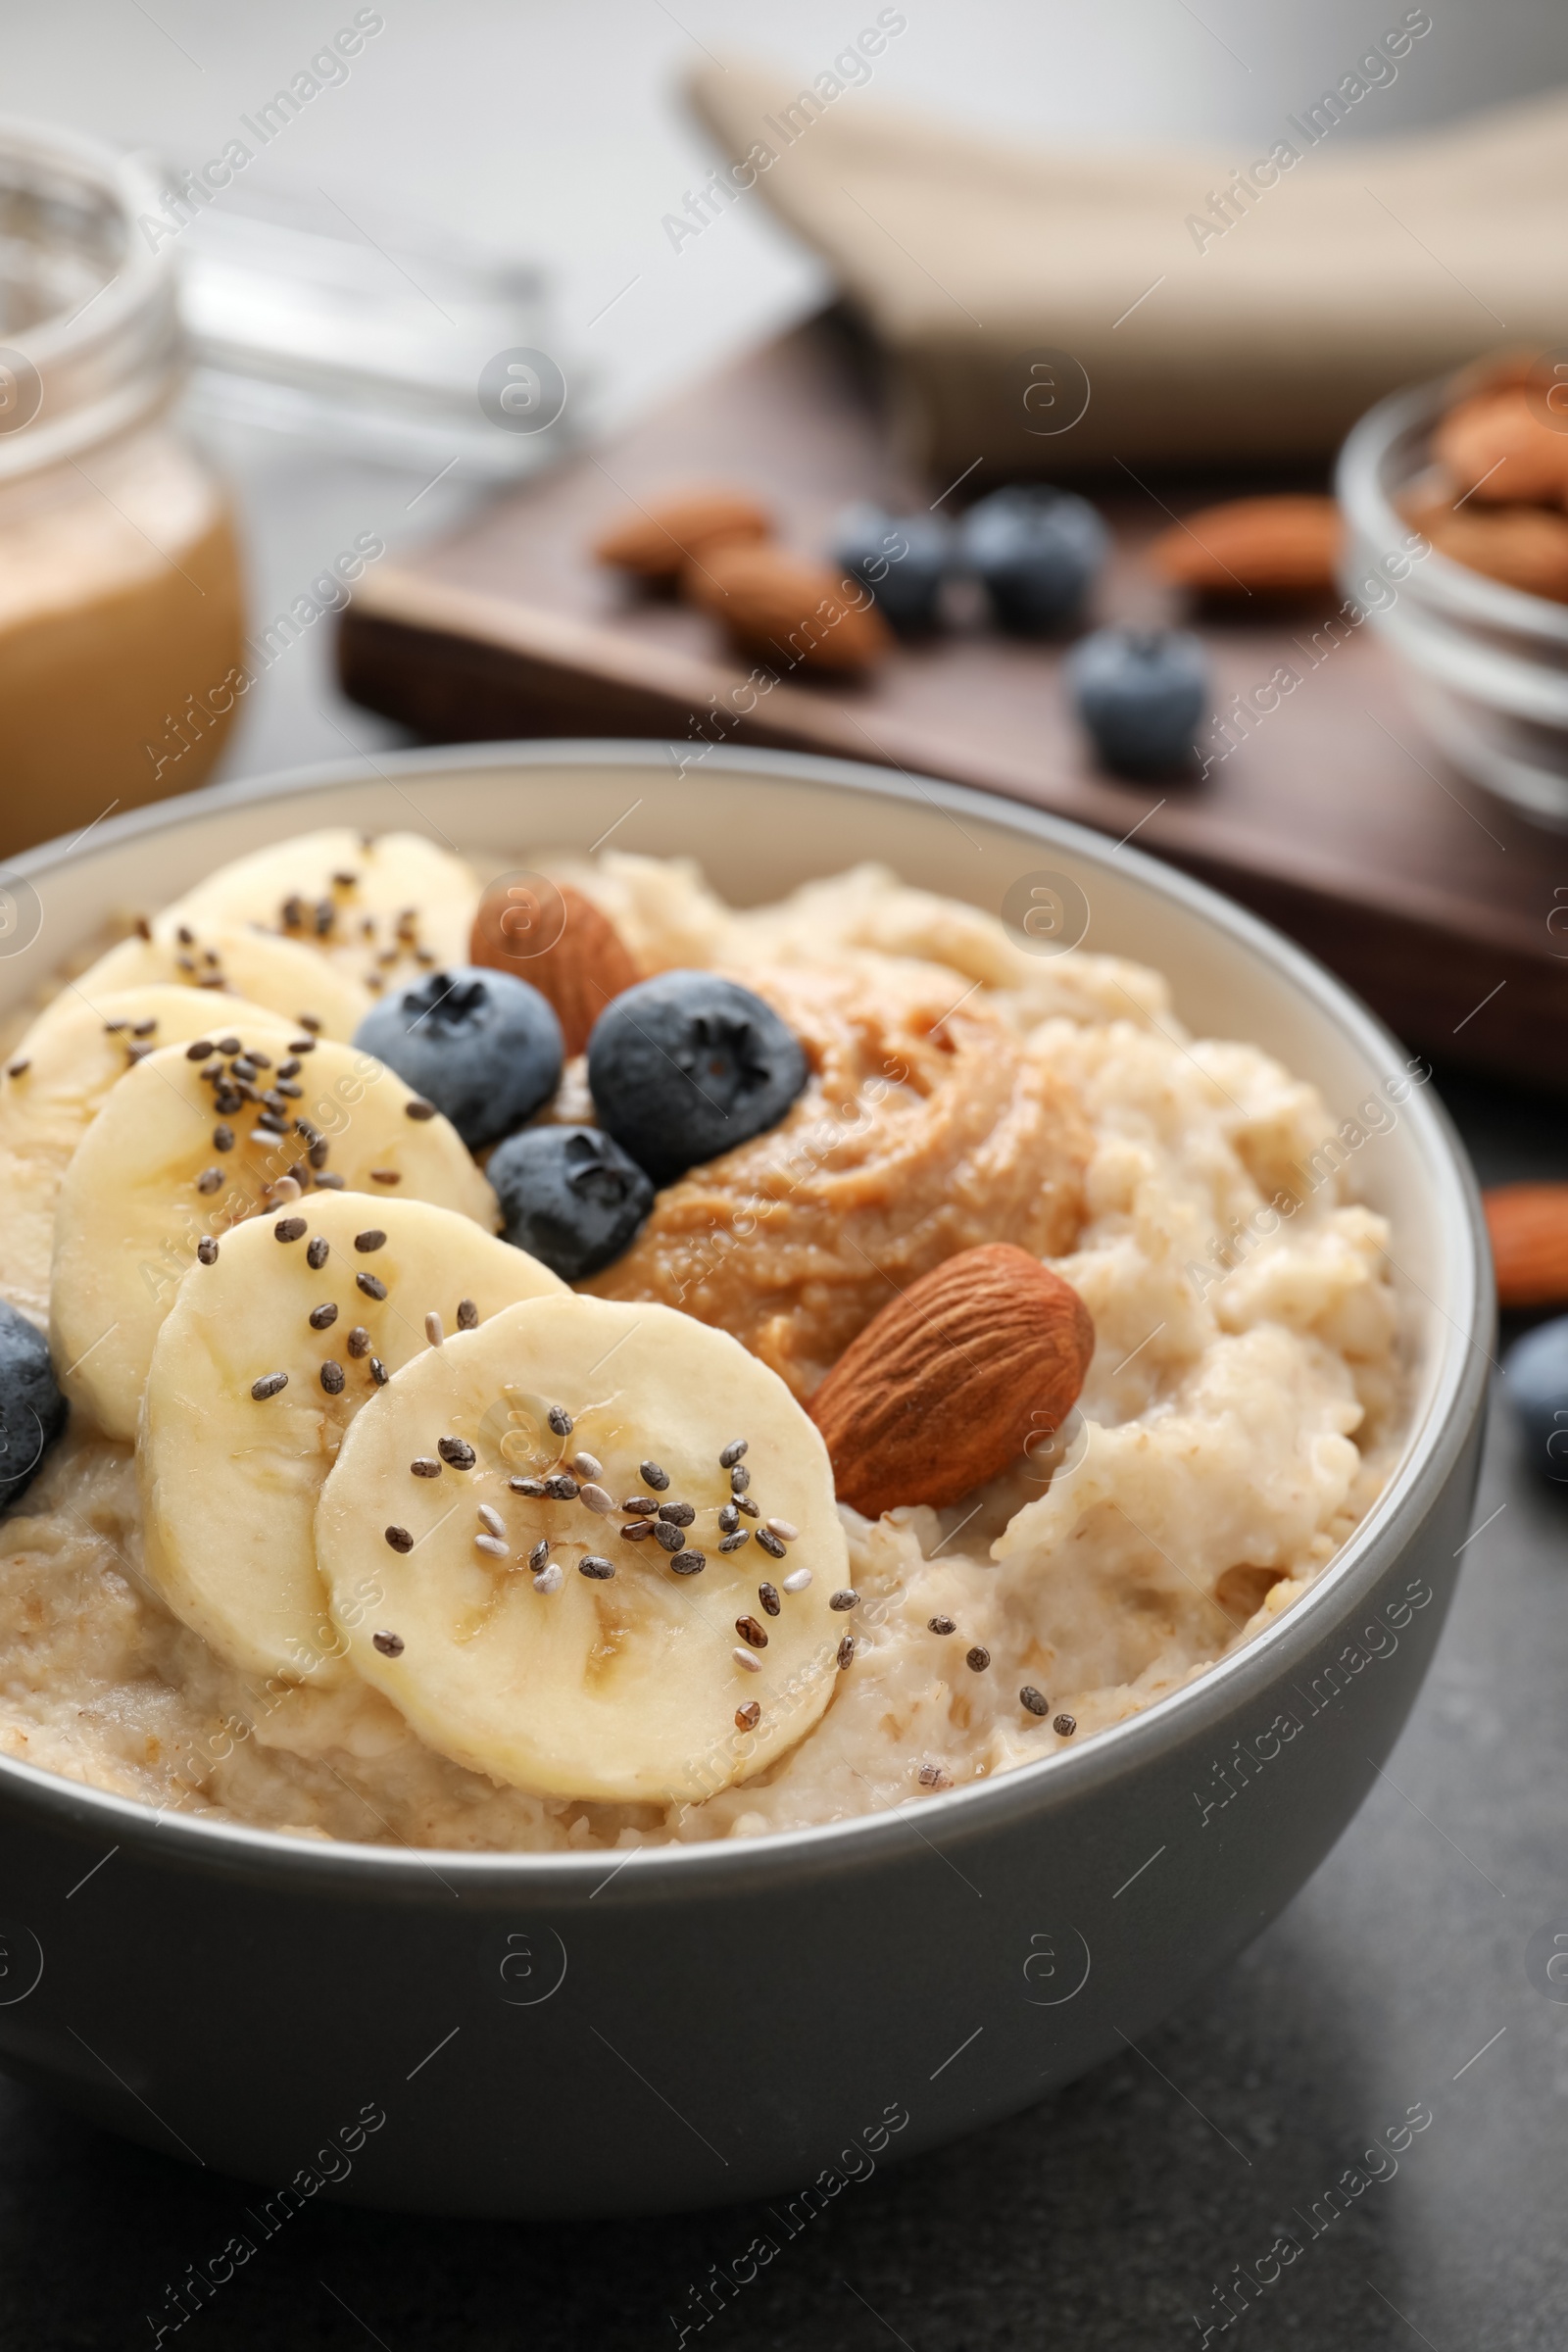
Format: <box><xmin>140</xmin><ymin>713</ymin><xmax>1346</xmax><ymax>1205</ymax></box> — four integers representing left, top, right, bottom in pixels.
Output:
<box><xmin>588</xmin><ymin>971</ymin><xmax>807</xmax><ymax>1183</ymax></box>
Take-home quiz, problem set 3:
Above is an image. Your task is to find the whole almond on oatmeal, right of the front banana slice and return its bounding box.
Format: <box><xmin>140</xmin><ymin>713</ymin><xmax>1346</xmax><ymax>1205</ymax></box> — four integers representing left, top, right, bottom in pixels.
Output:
<box><xmin>807</xmin><ymin>1242</ymin><xmax>1096</xmax><ymax>1519</ymax></box>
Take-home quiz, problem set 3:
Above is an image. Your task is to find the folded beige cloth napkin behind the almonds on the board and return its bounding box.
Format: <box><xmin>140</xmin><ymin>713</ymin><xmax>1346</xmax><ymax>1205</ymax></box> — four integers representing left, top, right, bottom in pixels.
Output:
<box><xmin>691</xmin><ymin>61</ymin><xmax>1568</xmax><ymax>475</ymax></box>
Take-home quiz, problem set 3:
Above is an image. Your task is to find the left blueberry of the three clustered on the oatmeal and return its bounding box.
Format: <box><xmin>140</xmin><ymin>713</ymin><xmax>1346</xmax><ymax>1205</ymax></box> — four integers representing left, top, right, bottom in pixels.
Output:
<box><xmin>355</xmin><ymin>964</ymin><xmax>562</xmax><ymax>1151</ymax></box>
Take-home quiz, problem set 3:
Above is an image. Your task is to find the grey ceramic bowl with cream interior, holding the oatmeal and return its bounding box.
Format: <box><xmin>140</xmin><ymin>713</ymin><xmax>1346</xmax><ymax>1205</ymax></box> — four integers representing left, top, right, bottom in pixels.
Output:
<box><xmin>0</xmin><ymin>743</ymin><xmax>1491</xmax><ymax>2230</ymax></box>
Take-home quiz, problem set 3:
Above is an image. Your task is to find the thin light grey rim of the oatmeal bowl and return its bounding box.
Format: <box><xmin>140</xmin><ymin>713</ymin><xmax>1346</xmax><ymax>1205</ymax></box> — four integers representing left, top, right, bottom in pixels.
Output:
<box><xmin>0</xmin><ymin>736</ymin><xmax>1495</xmax><ymax>1907</ymax></box>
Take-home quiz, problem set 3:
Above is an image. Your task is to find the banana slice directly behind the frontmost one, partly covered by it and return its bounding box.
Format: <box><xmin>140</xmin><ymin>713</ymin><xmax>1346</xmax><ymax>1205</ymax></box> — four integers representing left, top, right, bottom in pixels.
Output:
<box><xmin>136</xmin><ymin>1193</ymin><xmax>566</xmax><ymax>1687</ymax></box>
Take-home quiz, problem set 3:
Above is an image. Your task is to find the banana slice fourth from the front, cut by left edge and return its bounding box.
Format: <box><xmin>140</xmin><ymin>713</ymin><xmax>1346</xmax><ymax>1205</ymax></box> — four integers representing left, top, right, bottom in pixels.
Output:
<box><xmin>0</xmin><ymin>986</ymin><xmax>289</xmax><ymax>1324</ymax></box>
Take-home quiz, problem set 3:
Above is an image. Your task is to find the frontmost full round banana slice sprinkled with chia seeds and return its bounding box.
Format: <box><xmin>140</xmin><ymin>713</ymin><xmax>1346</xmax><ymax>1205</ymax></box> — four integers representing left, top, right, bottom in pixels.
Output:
<box><xmin>315</xmin><ymin>1296</ymin><xmax>854</xmax><ymax>1804</ymax></box>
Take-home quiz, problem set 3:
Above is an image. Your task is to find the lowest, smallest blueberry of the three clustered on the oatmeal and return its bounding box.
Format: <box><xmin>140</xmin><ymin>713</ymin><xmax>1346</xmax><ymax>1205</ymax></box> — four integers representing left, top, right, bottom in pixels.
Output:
<box><xmin>496</xmin><ymin>1127</ymin><xmax>654</xmax><ymax>1282</ymax></box>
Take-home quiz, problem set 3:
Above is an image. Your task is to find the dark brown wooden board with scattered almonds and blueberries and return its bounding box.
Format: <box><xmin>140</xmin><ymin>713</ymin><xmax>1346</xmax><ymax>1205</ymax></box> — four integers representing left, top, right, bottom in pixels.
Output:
<box><xmin>338</xmin><ymin>303</ymin><xmax>1568</xmax><ymax>1089</ymax></box>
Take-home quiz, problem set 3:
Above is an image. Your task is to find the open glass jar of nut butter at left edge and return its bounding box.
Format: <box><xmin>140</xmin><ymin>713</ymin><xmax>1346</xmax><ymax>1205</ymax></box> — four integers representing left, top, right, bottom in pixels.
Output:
<box><xmin>0</xmin><ymin>120</ymin><xmax>247</xmax><ymax>857</ymax></box>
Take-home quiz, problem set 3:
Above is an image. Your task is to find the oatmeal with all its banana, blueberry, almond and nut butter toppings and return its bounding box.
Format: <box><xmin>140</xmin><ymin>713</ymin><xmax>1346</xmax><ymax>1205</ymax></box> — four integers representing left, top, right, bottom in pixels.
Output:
<box><xmin>0</xmin><ymin>833</ymin><xmax>1403</xmax><ymax>1851</ymax></box>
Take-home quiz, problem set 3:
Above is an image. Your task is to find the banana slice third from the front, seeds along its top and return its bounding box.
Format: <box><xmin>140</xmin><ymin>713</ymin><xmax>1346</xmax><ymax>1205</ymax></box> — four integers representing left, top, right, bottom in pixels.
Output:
<box><xmin>49</xmin><ymin>1039</ymin><xmax>501</xmax><ymax>1440</ymax></box>
